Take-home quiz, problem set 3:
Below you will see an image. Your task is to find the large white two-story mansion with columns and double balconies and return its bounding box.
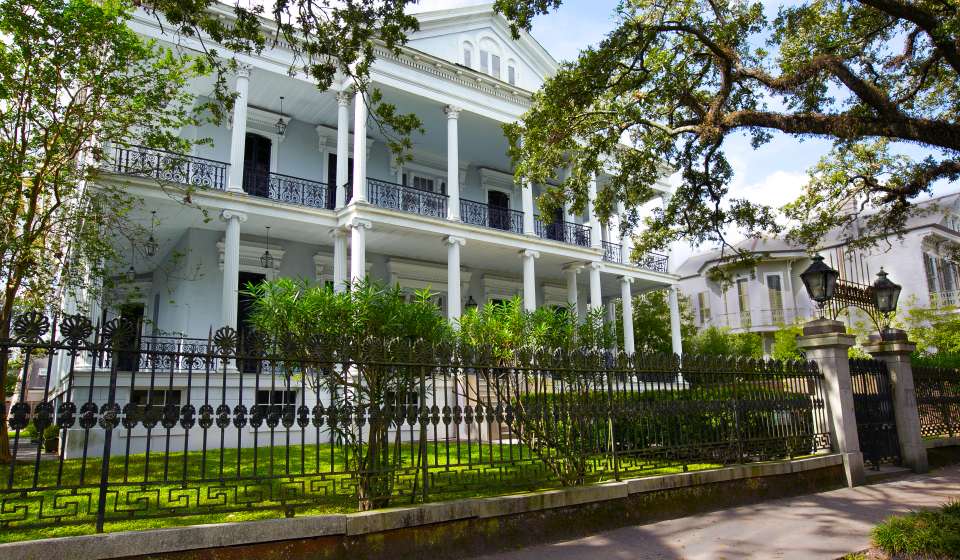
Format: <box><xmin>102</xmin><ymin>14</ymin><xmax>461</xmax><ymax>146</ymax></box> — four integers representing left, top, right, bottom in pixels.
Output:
<box><xmin>84</xmin><ymin>5</ymin><xmax>680</xmax><ymax>352</ymax></box>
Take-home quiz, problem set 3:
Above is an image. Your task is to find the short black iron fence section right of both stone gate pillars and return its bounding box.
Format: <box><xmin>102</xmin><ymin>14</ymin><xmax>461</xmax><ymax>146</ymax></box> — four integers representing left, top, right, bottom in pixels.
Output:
<box><xmin>913</xmin><ymin>364</ymin><xmax>960</xmax><ymax>438</ymax></box>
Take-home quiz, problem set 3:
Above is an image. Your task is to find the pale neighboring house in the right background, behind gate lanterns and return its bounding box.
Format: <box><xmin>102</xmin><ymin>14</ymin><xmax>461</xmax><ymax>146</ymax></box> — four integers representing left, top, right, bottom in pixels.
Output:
<box><xmin>676</xmin><ymin>193</ymin><xmax>960</xmax><ymax>351</ymax></box>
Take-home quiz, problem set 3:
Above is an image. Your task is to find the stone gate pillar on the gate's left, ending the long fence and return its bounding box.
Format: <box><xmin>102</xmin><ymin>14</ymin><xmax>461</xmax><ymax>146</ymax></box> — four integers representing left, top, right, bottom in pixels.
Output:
<box><xmin>797</xmin><ymin>319</ymin><xmax>866</xmax><ymax>486</ymax></box>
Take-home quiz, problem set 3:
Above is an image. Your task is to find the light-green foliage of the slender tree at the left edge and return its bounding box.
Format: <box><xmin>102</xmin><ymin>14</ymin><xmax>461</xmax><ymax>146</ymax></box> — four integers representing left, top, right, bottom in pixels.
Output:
<box><xmin>0</xmin><ymin>0</ymin><xmax>208</xmax><ymax>460</ymax></box>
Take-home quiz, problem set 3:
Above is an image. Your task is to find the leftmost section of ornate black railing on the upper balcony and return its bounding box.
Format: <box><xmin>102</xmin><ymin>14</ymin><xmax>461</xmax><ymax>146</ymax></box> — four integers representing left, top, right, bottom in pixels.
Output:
<box><xmin>107</xmin><ymin>146</ymin><xmax>229</xmax><ymax>190</ymax></box>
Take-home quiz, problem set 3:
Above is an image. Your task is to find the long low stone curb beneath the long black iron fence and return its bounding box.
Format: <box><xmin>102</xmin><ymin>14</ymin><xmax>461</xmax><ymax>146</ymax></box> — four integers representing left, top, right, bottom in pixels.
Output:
<box><xmin>0</xmin><ymin>454</ymin><xmax>843</xmax><ymax>560</ymax></box>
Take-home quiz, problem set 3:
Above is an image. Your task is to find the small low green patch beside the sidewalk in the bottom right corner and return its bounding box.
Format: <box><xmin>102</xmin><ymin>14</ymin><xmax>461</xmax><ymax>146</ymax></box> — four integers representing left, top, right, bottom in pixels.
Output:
<box><xmin>873</xmin><ymin>500</ymin><xmax>960</xmax><ymax>559</ymax></box>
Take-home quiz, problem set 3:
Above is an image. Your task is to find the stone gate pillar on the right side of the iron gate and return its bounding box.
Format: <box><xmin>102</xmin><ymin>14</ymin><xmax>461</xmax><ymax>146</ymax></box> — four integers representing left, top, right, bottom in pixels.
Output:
<box><xmin>863</xmin><ymin>329</ymin><xmax>930</xmax><ymax>473</ymax></box>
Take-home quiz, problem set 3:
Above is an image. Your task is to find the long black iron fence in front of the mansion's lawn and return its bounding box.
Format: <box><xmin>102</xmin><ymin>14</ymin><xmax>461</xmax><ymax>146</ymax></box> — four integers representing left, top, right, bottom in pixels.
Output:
<box><xmin>0</xmin><ymin>314</ymin><xmax>830</xmax><ymax>530</ymax></box>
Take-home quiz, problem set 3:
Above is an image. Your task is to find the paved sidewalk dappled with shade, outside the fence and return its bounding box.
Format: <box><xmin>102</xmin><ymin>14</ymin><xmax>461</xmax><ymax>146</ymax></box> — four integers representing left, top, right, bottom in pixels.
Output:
<box><xmin>484</xmin><ymin>465</ymin><xmax>960</xmax><ymax>560</ymax></box>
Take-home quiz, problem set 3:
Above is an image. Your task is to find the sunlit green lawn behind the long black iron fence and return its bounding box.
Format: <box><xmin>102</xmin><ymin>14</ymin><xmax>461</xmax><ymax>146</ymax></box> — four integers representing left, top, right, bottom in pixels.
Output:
<box><xmin>0</xmin><ymin>441</ymin><xmax>720</xmax><ymax>542</ymax></box>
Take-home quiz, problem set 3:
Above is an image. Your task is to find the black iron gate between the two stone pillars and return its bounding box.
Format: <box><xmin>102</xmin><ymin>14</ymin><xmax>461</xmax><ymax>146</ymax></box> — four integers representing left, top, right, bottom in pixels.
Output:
<box><xmin>850</xmin><ymin>359</ymin><xmax>900</xmax><ymax>469</ymax></box>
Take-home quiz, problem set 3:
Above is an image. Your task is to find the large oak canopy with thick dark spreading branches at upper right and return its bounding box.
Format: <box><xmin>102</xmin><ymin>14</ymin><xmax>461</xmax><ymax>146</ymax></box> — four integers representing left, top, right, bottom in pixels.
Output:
<box><xmin>496</xmin><ymin>0</ymin><xmax>960</xmax><ymax>253</ymax></box>
